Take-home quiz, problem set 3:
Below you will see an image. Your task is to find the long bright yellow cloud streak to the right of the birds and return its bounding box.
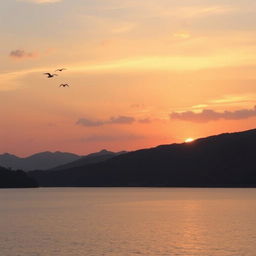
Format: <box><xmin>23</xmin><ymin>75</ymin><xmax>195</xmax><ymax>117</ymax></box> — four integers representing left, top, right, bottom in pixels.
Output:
<box><xmin>73</xmin><ymin>52</ymin><xmax>256</xmax><ymax>72</ymax></box>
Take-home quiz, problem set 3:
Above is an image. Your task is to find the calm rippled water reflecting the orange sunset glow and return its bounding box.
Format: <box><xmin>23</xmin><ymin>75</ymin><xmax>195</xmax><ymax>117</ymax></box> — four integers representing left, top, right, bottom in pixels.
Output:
<box><xmin>0</xmin><ymin>188</ymin><xmax>256</xmax><ymax>256</ymax></box>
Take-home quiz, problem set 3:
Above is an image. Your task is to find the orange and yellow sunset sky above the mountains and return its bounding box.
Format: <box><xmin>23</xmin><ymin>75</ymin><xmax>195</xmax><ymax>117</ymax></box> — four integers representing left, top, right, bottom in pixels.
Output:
<box><xmin>0</xmin><ymin>0</ymin><xmax>256</xmax><ymax>156</ymax></box>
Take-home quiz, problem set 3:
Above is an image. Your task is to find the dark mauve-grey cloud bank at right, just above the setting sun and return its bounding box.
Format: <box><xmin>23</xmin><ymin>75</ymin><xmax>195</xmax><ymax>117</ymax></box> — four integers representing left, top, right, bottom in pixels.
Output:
<box><xmin>170</xmin><ymin>106</ymin><xmax>256</xmax><ymax>123</ymax></box>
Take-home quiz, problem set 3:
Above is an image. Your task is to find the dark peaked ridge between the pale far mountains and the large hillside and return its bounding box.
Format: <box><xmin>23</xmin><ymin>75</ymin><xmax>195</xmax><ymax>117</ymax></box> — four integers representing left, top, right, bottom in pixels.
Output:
<box><xmin>51</xmin><ymin>149</ymin><xmax>127</xmax><ymax>171</ymax></box>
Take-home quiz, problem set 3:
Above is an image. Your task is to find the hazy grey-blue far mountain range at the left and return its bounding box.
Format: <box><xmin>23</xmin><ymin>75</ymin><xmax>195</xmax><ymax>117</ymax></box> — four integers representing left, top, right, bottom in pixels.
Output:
<box><xmin>0</xmin><ymin>152</ymin><xmax>81</xmax><ymax>171</ymax></box>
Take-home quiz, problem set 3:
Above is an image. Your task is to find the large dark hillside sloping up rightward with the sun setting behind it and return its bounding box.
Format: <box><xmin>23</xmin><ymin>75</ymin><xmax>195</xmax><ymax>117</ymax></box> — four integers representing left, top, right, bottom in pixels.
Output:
<box><xmin>29</xmin><ymin>129</ymin><xmax>256</xmax><ymax>187</ymax></box>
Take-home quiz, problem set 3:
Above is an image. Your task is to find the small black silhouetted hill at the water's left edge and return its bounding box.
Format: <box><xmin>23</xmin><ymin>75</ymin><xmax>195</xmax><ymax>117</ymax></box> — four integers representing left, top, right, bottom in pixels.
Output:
<box><xmin>0</xmin><ymin>167</ymin><xmax>38</xmax><ymax>188</ymax></box>
